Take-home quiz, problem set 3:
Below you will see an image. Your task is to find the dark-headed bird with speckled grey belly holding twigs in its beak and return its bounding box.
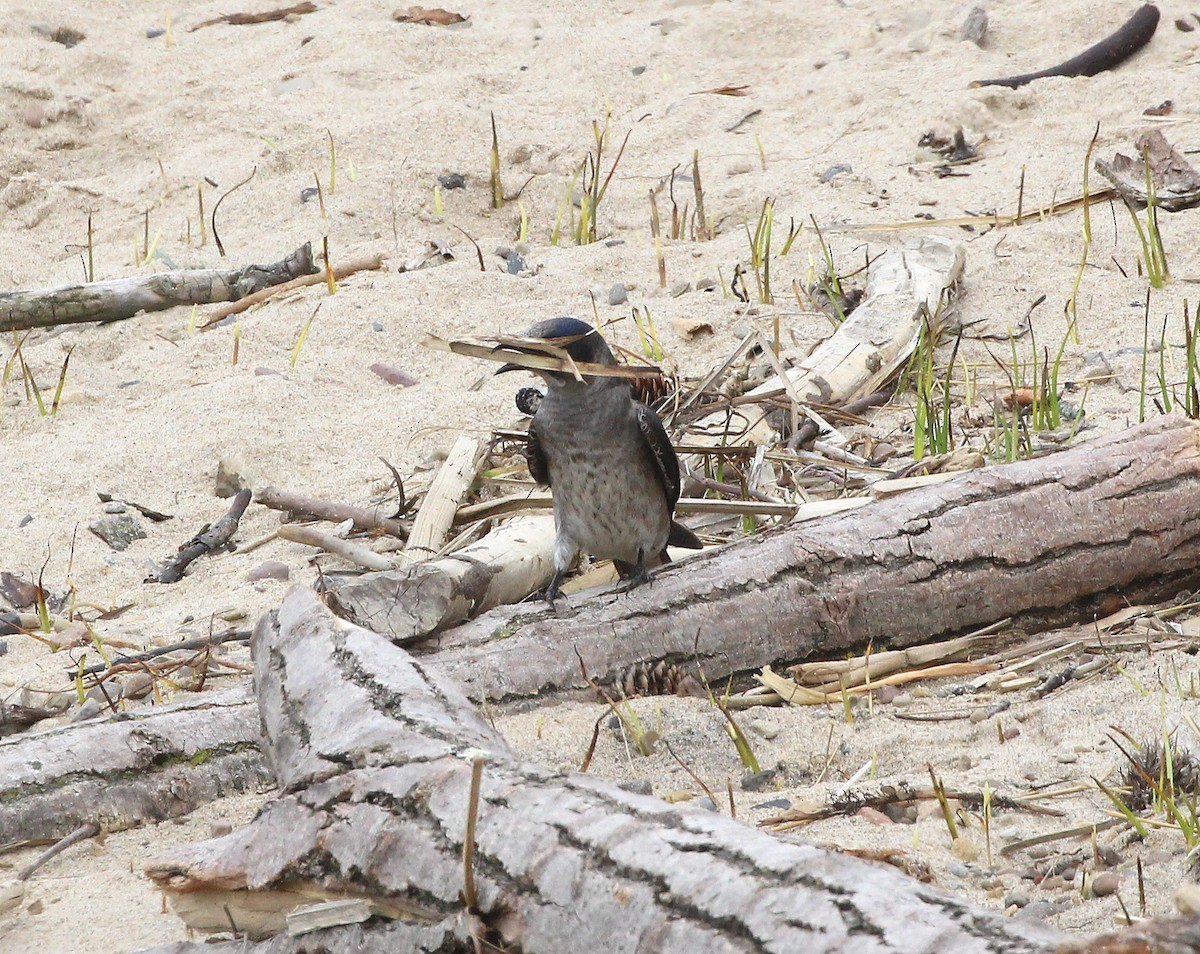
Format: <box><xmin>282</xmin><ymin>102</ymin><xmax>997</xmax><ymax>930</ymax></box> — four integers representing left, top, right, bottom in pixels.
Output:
<box><xmin>497</xmin><ymin>317</ymin><xmax>703</xmax><ymax>606</ymax></box>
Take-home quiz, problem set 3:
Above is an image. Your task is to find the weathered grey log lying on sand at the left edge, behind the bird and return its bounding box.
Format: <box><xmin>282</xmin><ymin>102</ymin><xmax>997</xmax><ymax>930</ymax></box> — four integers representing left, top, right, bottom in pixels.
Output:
<box><xmin>0</xmin><ymin>242</ymin><xmax>317</xmax><ymax>332</ymax></box>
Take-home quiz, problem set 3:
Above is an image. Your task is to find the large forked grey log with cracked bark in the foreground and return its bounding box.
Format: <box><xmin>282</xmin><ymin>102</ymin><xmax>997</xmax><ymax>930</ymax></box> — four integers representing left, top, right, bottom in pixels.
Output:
<box><xmin>140</xmin><ymin>587</ymin><xmax>1062</xmax><ymax>954</ymax></box>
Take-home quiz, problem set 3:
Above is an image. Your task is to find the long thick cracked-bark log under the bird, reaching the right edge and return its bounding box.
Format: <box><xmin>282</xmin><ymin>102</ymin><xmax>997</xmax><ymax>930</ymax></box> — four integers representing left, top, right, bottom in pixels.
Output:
<box><xmin>420</xmin><ymin>418</ymin><xmax>1200</xmax><ymax>698</ymax></box>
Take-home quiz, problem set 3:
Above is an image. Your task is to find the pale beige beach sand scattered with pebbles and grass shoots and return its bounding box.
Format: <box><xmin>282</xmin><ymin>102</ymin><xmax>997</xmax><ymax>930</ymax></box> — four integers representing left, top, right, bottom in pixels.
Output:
<box><xmin>0</xmin><ymin>0</ymin><xmax>1200</xmax><ymax>954</ymax></box>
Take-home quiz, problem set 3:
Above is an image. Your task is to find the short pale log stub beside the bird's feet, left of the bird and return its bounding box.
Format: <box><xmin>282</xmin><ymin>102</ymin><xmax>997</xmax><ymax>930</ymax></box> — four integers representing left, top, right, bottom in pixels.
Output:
<box><xmin>329</xmin><ymin>516</ymin><xmax>554</xmax><ymax>644</ymax></box>
